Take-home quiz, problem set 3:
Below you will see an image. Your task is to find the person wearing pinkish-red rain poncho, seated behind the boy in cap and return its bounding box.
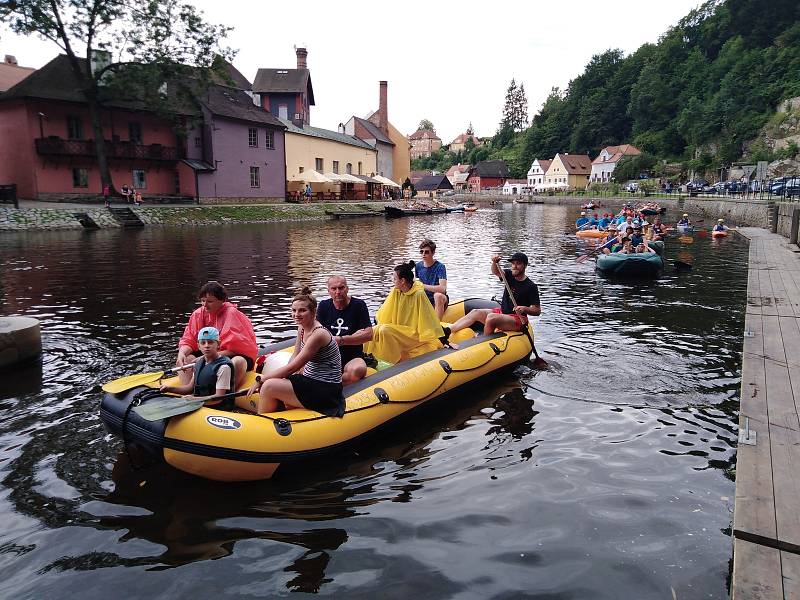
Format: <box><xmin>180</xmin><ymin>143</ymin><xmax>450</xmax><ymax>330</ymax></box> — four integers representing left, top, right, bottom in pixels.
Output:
<box><xmin>175</xmin><ymin>281</ymin><xmax>258</xmax><ymax>389</ymax></box>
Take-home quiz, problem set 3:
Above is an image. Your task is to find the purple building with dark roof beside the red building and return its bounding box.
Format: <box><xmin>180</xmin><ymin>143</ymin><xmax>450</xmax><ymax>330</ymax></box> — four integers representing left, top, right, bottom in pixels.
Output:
<box><xmin>183</xmin><ymin>83</ymin><xmax>286</xmax><ymax>204</ymax></box>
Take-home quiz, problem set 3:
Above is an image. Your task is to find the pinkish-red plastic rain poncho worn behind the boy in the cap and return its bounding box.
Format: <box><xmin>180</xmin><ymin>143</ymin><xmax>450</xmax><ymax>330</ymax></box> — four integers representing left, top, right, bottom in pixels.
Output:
<box><xmin>178</xmin><ymin>302</ymin><xmax>258</xmax><ymax>361</ymax></box>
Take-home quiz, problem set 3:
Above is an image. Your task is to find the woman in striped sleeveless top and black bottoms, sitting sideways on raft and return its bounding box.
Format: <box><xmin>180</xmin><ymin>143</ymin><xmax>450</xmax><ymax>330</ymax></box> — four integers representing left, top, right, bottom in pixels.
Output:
<box><xmin>241</xmin><ymin>287</ymin><xmax>344</xmax><ymax>417</ymax></box>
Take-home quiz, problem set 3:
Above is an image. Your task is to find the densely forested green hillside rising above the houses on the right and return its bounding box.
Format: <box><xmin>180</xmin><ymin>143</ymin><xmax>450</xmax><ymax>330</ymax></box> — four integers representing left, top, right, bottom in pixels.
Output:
<box><xmin>418</xmin><ymin>0</ymin><xmax>800</xmax><ymax>176</ymax></box>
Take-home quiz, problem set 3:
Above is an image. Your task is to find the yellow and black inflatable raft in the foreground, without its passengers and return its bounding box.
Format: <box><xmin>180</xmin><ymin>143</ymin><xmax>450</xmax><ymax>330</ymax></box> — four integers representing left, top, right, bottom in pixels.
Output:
<box><xmin>100</xmin><ymin>299</ymin><xmax>533</xmax><ymax>481</ymax></box>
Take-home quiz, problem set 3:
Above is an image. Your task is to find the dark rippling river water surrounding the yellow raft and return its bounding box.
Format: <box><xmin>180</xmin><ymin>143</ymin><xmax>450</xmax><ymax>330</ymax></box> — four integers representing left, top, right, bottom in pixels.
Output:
<box><xmin>0</xmin><ymin>205</ymin><xmax>747</xmax><ymax>599</ymax></box>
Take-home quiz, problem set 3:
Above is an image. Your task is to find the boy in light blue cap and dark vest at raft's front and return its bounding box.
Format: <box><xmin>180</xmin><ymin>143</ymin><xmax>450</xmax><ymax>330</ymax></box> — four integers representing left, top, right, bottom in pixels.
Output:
<box><xmin>160</xmin><ymin>327</ymin><xmax>233</xmax><ymax>398</ymax></box>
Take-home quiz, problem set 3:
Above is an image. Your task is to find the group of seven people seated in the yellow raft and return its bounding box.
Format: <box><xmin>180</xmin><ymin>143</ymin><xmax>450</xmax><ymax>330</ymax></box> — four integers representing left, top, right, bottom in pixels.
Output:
<box><xmin>161</xmin><ymin>239</ymin><xmax>541</xmax><ymax>417</ymax></box>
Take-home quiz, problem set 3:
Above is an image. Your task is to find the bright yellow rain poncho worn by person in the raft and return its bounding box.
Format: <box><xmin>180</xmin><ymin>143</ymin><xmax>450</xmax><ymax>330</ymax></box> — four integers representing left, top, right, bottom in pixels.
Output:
<box><xmin>364</xmin><ymin>281</ymin><xmax>444</xmax><ymax>363</ymax></box>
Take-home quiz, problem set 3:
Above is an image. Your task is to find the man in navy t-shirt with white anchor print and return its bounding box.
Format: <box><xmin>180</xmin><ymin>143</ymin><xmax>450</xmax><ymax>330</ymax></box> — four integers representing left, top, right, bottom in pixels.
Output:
<box><xmin>317</xmin><ymin>275</ymin><xmax>372</xmax><ymax>385</ymax></box>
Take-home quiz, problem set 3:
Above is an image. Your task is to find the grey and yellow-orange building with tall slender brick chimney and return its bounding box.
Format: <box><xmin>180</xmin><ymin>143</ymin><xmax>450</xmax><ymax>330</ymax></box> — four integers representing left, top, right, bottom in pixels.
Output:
<box><xmin>344</xmin><ymin>81</ymin><xmax>411</xmax><ymax>183</ymax></box>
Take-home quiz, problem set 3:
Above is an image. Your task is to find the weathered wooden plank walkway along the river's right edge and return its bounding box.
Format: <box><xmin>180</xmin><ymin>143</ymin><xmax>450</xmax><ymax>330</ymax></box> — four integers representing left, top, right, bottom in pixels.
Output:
<box><xmin>731</xmin><ymin>227</ymin><xmax>800</xmax><ymax>600</ymax></box>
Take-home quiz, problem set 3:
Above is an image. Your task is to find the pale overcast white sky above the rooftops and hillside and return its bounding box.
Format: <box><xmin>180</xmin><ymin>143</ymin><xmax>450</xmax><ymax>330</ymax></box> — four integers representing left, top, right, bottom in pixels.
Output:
<box><xmin>0</xmin><ymin>0</ymin><xmax>699</xmax><ymax>144</ymax></box>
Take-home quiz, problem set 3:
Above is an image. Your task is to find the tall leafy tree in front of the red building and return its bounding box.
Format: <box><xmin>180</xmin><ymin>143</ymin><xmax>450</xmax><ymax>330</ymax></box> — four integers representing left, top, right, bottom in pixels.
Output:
<box><xmin>0</xmin><ymin>0</ymin><xmax>233</xmax><ymax>187</ymax></box>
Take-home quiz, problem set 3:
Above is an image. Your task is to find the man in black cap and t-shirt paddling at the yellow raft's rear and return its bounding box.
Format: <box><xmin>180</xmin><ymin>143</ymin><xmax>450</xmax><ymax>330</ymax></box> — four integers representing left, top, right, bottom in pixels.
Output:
<box><xmin>445</xmin><ymin>252</ymin><xmax>542</xmax><ymax>335</ymax></box>
